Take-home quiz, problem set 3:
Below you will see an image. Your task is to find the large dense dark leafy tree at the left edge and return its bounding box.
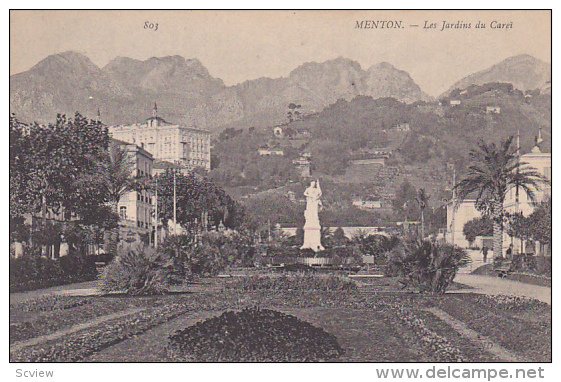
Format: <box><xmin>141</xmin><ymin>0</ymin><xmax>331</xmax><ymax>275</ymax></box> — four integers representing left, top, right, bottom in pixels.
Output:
<box><xmin>10</xmin><ymin>113</ymin><xmax>109</xmax><ymax>252</ymax></box>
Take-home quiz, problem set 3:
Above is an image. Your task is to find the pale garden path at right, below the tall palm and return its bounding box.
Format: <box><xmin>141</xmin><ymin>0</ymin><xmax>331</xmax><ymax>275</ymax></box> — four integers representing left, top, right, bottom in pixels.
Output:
<box><xmin>450</xmin><ymin>273</ymin><xmax>551</xmax><ymax>305</ymax></box>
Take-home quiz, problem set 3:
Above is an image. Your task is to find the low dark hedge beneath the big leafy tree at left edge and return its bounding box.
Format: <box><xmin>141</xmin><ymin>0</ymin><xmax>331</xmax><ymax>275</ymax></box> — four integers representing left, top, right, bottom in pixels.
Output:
<box><xmin>10</xmin><ymin>256</ymin><xmax>98</xmax><ymax>292</ymax></box>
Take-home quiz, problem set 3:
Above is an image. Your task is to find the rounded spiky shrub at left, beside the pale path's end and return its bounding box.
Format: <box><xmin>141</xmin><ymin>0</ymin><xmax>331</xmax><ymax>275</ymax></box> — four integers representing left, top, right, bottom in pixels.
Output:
<box><xmin>100</xmin><ymin>245</ymin><xmax>173</xmax><ymax>295</ymax></box>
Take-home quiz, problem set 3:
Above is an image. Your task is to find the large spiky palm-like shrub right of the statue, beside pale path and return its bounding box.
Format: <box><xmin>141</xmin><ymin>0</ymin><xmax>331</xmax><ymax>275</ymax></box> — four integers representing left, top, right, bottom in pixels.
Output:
<box><xmin>387</xmin><ymin>240</ymin><xmax>471</xmax><ymax>294</ymax></box>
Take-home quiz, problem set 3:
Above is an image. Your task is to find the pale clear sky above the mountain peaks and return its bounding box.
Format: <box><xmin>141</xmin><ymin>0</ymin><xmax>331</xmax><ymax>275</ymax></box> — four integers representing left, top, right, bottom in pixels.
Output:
<box><xmin>10</xmin><ymin>11</ymin><xmax>551</xmax><ymax>96</ymax></box>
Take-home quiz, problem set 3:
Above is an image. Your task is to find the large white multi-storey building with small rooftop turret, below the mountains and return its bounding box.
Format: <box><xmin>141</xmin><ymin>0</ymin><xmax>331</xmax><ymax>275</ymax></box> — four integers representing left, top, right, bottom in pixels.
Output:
<box><xmin>109</xmin><ymin>105</ymin><xmax>210</xmax><ymax>170</ymax></box>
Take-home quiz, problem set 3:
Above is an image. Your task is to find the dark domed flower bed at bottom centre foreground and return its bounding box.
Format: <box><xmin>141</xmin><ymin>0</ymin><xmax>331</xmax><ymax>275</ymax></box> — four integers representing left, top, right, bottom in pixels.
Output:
<box><xmin>169</xmin><ymin>308</ymin><xmax>343</xmax><ymax>362</ymax></box>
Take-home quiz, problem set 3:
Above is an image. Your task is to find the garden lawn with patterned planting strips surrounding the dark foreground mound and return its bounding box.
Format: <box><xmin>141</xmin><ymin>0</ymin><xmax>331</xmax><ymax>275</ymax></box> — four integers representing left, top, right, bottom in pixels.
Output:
<box><xmin>10</xmin><ymin>278</ymin><xmax>551</xmax><ymax>362</ymax></box>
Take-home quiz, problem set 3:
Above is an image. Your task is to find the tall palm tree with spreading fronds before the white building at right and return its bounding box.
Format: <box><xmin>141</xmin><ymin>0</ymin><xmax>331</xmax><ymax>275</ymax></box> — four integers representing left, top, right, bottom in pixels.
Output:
<box><xmin>454</xmin><ymin>136</ymin><xmax>546</xmax><ymax>257</ymax></box>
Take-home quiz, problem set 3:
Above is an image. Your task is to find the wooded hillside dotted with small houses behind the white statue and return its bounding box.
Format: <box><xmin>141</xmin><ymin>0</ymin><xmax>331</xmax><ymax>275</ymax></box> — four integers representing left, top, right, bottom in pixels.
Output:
<box><xmin>211</xmin><ymin>83</ymin><xmax>551</xmax><ymax>224</ymax></box>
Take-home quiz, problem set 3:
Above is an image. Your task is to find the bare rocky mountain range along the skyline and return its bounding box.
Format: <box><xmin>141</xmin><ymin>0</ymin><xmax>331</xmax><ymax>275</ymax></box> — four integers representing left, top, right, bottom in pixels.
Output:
<box><xmin>10</xmin><ymin>52</ymin><xmax>551</xmax><ymax>132</ymax></box>
